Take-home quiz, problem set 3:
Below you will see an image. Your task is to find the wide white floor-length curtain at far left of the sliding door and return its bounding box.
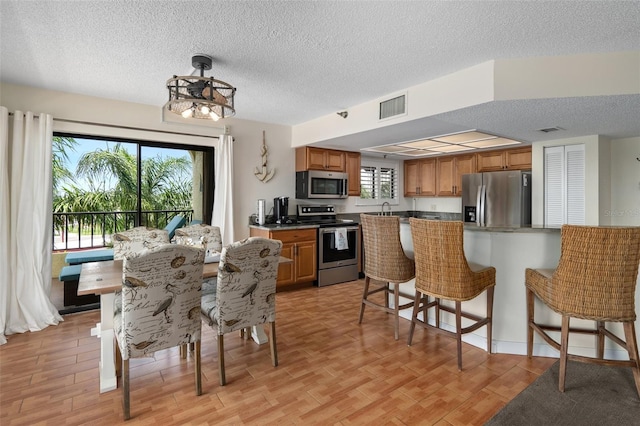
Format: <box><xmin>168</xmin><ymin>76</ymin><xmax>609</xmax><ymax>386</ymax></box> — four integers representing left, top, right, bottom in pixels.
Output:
<box><xmin>0</xmin><ymin>107</ymin><xmax>62</xmax><ymax>344</ymax></box>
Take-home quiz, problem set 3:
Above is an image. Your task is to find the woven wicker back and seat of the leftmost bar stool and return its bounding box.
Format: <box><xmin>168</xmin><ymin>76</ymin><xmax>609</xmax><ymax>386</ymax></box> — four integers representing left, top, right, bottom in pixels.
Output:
<box><xmin>360</xmin><ymin>214</ymin><xmax>415</xmax><ymax>283</ymax></box>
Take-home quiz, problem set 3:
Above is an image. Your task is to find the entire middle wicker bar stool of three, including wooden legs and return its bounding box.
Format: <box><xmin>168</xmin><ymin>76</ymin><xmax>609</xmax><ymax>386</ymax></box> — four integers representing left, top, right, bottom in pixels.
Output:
<box><xmin>407</xmin><ymin>218</ymin><xmax>496</xmax><ymax>370</ymax></box>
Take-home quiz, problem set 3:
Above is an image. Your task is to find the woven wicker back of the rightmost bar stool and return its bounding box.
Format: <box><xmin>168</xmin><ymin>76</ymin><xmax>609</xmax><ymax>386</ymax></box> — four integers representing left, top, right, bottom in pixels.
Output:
<box><xmin>549</xmin><ymin>225</ymin><xmax>640</xmax><ymax>321</ymax></box>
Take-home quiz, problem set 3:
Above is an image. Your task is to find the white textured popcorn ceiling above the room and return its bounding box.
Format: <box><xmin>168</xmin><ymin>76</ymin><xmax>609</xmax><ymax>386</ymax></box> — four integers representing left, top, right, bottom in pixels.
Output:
<box><xmin>0</xmin><ymin>0</ymin><xmax>640</xmax><ymax>147</ymax></box>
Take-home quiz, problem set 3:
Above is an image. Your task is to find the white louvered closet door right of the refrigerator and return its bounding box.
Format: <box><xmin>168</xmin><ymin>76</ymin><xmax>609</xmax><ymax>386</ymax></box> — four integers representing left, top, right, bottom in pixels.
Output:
<box><xmin>544</xmin><ymin>144</ymin><xmax>585</xmax><ymax>226</ymax></box>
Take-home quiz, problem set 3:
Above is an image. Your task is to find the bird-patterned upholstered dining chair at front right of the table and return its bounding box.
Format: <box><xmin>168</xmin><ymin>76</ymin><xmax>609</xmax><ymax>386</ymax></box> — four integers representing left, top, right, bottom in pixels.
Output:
<box><xmin>201</xmin><ymin>237</ymin><xmax>282</xmax><ymax>386</ymax></box>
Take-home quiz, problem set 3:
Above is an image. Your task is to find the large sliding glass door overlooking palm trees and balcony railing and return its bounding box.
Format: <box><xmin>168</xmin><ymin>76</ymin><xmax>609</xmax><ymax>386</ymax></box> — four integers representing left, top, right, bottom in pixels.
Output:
<box><xmin>52</xmin><ymin>132</ymin><xmax>214</xmax><ymax>250</ymax></box>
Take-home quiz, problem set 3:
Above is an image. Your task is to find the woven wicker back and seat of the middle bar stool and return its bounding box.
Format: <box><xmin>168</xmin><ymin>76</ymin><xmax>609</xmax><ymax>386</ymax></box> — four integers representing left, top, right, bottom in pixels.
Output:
<box><xmin>409</xmin><ymin>218</ymin><xmax>488</xmax><ymax>301</ymax></box>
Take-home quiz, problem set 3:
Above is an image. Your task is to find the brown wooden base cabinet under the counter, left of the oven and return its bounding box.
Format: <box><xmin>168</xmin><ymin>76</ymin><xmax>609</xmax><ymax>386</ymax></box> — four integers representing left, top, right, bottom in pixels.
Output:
<box><xmin>249</xmin><ymin>228</ymin><xmax>318</xmax><ymax>289</ymax></box>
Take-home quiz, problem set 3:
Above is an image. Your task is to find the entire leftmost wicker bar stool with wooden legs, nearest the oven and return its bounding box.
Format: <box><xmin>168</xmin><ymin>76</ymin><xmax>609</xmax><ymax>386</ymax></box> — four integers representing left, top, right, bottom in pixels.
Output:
<box><xmin>358</xmin><ymin>214</ymin><xmax>415</xmax><ymax>340</ymax></box>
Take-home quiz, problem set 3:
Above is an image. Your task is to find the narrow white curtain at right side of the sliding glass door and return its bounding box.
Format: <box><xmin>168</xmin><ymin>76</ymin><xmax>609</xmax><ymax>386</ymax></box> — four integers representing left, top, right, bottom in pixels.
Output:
<box><xmin>211</xmin><ymin>135</ymin><xmax>235</xmax><ymax>246</ymax></box>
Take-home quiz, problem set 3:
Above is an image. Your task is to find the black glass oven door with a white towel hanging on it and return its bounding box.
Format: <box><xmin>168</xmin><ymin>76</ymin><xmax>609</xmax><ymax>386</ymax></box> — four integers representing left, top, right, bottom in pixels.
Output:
<box><xmin>318</xmin><ymin>226</ymin><xmax>359</xmax><ymax>269</ymax></box>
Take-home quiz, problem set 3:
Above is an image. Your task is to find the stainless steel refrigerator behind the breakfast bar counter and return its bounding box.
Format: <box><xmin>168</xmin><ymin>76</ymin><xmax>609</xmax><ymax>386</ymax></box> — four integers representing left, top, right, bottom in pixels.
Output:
<box><xmin>462</xmin><ymin>170</ymin><xmax>531</xmax><ymax>226</ymax></box>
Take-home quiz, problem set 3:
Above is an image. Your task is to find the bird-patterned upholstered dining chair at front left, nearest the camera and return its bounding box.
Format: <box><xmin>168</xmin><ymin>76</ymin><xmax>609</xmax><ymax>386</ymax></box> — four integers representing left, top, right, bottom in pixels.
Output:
<box><xmin>113</xmin><ymin>244</ymin><xmax>204</xmax><ymax>419</ymax></box>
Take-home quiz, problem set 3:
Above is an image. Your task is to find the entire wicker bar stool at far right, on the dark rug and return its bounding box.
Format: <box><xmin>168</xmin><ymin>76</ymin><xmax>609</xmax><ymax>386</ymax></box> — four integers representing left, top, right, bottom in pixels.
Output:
<box><xmin>525</xmin><ymin>225</ymin><xmax>640</xmax><ymax>396</ymax></box>
